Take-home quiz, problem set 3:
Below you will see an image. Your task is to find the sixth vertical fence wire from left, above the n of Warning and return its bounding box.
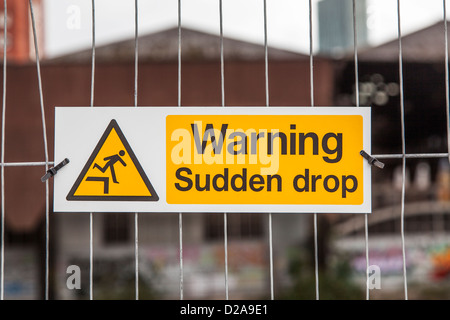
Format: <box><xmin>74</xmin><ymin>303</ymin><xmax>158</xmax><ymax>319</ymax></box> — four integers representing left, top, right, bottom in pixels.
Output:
<box><xmin>219</xmin><ymin>0</ymin><xmax>228</xmax><ymax>300</ymax></box>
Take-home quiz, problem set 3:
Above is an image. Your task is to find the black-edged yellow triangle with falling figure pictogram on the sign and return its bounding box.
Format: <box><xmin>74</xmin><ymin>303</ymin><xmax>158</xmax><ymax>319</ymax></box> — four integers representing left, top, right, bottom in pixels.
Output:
<box><xmin>67</xmin><ymin>120</ymin><xmax>159</xmax><ymax>201</ymax></box>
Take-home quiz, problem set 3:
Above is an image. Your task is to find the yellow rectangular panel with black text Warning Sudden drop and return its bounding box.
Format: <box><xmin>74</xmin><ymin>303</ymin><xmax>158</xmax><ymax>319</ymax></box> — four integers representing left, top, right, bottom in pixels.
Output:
<box><xmin>166</xmin><ymin>115</ymin><xmax>364</xmax><ymax>205</ymax></box>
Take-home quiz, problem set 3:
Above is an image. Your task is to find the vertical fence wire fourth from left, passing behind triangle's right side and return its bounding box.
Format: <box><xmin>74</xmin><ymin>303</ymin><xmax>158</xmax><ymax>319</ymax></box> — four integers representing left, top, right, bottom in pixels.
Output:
<box><xmin>134</xmin><ymin>0</ymin><xmax>139</xmax><ymax>300</ymax></box>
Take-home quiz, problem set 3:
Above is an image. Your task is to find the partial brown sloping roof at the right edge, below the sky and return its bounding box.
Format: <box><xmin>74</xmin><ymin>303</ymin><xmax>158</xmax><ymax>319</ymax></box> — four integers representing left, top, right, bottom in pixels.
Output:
<box><xmin>358</xmin><ymin>20</ymin><xmax>445</xmax><ymax>62</ymax></box>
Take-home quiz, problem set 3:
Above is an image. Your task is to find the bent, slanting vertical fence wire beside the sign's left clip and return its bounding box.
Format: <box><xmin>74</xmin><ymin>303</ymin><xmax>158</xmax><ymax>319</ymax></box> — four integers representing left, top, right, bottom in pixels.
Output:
<box><xmin>29</xmin><ymin>0</ymin><xmax>49</xmax><ymax>300</ymax></box>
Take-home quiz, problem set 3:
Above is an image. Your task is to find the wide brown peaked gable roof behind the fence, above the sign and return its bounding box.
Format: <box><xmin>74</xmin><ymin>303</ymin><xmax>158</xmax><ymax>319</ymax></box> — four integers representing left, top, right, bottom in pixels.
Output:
<box><xmin>47</xmin><ymin>28</ymin><xmax>307</xmax><ymax>63</ymax></box>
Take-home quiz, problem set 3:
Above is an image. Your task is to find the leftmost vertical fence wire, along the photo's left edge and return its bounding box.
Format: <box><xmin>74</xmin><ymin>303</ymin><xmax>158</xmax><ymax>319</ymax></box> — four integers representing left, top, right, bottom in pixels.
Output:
<box><xmin>0</xmin><ymin>0</ymin><xmax>8</xmax><ymax>300</ymax></box>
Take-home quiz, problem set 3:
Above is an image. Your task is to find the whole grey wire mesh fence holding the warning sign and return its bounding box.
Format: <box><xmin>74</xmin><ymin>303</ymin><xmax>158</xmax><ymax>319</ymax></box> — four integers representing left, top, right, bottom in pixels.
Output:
<box><xmin>0</xmin><ymin>0</ymin><xmax>450</xmax><ymax>300</ymax></box>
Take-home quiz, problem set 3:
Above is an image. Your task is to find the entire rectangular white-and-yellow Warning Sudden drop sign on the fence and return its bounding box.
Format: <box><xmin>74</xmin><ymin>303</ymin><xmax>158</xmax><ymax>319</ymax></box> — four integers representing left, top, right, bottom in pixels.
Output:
<box><xmin>54</xmin><ymin>107</ymin><xmax>371</xmax><ymax>213</ymax></box>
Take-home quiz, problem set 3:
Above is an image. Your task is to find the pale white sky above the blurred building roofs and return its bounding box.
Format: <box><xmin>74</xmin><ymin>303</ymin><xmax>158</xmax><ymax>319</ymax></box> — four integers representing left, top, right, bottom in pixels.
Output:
<box><xmin>44</xmin><ymin>0</ymin><xmax>443</xmax><ymax>57</ymax></box>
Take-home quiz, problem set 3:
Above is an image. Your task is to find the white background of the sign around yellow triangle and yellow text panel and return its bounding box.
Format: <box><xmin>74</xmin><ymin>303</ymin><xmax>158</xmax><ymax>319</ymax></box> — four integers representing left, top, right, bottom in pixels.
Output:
<box><xmin>53</xmin><ymin>106</ymin><xmax>372</xmax><ymax>213</ymax></box>
